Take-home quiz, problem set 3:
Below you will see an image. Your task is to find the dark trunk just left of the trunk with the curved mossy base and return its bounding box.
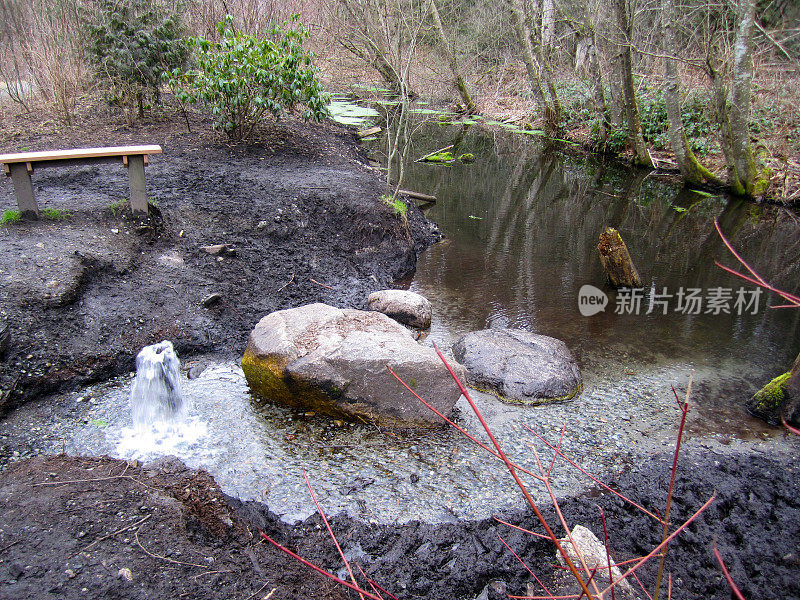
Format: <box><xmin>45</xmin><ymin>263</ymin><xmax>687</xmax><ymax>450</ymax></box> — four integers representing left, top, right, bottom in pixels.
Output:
<box><xmin>611</xmin><ymin>0</ymin><xmax>653</xmax><ymax>168</ymax></box>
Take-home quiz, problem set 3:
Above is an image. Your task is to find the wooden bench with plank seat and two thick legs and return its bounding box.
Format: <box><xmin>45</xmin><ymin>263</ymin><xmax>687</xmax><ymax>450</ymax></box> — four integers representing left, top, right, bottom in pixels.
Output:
<box><xmin>0</xmin><ymin>146</ymin><xmax>161</xmax><ymax>219</ymax></box>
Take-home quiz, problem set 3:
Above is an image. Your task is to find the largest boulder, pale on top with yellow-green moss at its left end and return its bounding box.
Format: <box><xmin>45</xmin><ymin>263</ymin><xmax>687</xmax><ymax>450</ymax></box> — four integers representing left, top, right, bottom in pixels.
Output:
<box><xmin>242</xmin><ymin>304</ymin><xmax>463</xmax><ymax>427</ymax></box>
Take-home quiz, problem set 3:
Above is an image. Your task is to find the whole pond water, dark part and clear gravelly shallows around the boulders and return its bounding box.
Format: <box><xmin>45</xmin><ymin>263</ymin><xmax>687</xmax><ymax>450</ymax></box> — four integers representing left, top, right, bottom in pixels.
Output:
<box><xmin>7</xmin><ymin>126</ymin><xmax>800</xmax><ymax>523</ymax></box>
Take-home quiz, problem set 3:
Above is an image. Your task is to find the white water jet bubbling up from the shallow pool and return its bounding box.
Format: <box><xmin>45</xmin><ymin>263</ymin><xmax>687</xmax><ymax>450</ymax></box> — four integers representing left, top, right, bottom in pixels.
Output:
<box><xmin>131</xmin><ymin>340</ymin><xmax>184</xmax><ymax>430</ymax></box>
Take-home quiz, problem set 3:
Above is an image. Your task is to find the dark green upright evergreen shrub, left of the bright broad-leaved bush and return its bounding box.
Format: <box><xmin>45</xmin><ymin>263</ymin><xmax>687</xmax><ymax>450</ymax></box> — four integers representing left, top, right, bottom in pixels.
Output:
<box><xmin>87</xmin><ymin>0</ymin><xmax>189</xmax><ymax>121</ymax></box>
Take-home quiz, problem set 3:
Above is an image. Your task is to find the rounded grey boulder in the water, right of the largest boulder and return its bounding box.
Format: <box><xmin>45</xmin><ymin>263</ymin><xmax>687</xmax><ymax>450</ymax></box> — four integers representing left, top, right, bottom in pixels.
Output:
<box><xmin>453</xmin><ymin>329</ymin><xmax>583</xmax><ymax>404</ymax></box>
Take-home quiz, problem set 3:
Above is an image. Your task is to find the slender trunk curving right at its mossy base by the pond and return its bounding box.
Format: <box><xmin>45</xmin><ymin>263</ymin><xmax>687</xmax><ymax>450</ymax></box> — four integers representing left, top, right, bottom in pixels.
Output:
<box><xmin>661</xmin><ymin>0</ymin><xmax>721</xmax><ymax>185</ymax></box>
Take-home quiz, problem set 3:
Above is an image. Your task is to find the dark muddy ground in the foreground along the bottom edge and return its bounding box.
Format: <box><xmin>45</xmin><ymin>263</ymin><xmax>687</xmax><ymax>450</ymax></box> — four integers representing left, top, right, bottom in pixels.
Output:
<box><xmin>0</xmin><ymin>449</ymin><xmax>800</xmax><ymax>600</ymax></box>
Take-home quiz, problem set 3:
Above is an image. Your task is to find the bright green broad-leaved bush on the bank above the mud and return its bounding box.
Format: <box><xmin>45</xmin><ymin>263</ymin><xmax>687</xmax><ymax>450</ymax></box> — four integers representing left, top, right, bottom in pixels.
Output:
<box><xmin>172</xmin><ymin>15</ymin><xmax>327</xmax><ymax>139</ymax></box>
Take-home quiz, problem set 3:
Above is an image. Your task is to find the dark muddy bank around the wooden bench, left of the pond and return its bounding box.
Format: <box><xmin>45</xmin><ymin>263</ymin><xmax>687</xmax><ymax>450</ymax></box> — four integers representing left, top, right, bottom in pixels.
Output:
<box><xmin>0</xmin><ymin>122</ymin><xmax>438</xmax><ymax>414</ymax></box>
